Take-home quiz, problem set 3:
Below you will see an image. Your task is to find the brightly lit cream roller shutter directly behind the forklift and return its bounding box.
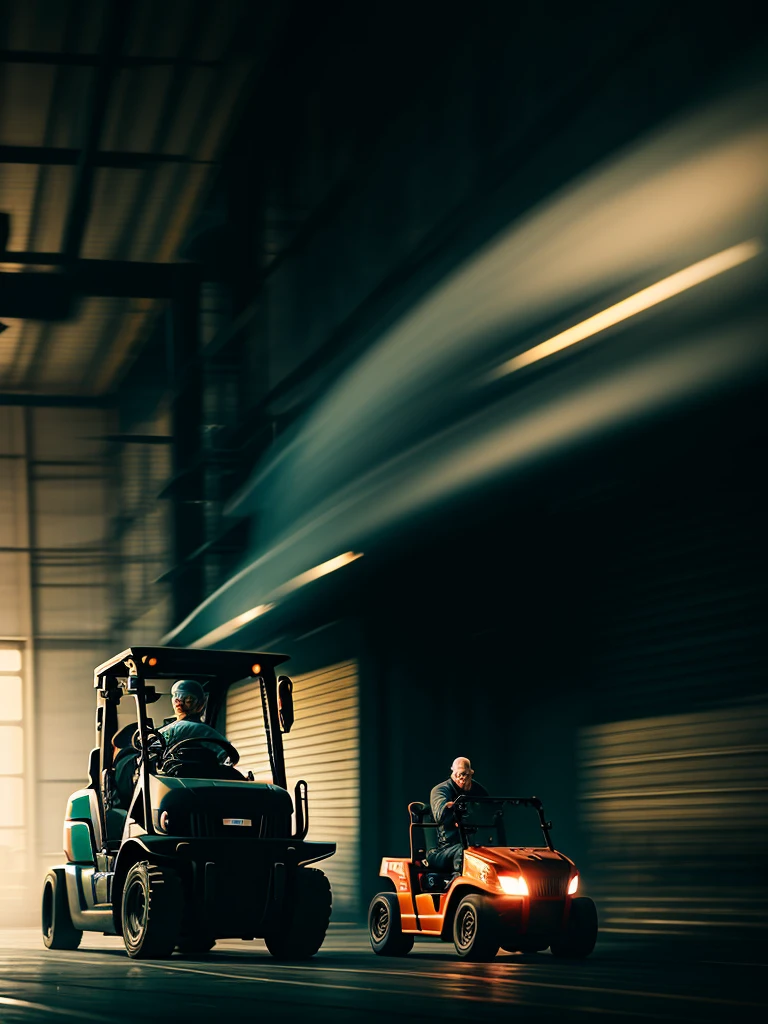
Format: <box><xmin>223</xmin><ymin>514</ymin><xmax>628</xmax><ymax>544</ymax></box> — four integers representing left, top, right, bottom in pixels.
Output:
<box><xmin>226</xmin><ymin>662</ymin><xmax>359</xmax><ymax>921</ymax></box>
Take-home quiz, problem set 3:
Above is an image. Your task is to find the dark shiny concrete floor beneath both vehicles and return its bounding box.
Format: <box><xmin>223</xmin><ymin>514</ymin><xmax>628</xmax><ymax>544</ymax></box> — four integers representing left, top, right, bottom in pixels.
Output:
<box><xmin>0</xmin><ymin>926</ymin><xmax>768</xmax><ymax>1024</ymax></box>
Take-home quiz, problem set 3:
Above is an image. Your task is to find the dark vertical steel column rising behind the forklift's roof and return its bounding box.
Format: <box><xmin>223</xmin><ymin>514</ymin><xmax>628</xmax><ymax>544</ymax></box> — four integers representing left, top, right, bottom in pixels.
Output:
<box><xmin>168</xmin><ymin>275</ymin><xmax>206</xmax><ymax>624</ymax></box>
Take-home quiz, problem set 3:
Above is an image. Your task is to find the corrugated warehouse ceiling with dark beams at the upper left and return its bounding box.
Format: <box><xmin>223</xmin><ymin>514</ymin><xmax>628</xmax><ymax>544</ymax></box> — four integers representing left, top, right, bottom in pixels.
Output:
<box><xmin>0</xmin><ymin>0</ymin><xmax>269</xmax><ymax>403</ymax></box>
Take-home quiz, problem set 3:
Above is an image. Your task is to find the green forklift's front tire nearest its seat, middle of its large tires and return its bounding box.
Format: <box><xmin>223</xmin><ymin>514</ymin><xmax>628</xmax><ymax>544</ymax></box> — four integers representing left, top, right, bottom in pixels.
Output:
<box><xmin>121</xmin><ymin>860</ymin><xmax>182</xmax><ymax>959</ymax></box>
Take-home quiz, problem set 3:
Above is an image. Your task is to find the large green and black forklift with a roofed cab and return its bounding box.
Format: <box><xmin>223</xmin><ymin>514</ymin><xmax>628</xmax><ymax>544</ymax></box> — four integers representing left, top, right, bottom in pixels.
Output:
<box><xmin>42</xmin><ymin>647</ymin><xmax>336</xmax><ymax>959</ymax></box>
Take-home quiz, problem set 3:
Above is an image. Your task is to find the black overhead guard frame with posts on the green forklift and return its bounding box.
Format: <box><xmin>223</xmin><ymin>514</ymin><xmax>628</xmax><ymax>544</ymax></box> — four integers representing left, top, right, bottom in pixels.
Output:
<box><xmin>89</xmin><ymin>647</ymin><xmax>294</xmax><ymax>836</ymax></box>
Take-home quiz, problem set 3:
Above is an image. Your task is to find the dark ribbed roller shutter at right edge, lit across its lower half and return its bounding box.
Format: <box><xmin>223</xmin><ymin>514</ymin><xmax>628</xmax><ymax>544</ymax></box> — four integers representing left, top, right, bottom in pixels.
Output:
<box><xmin>579</xmin><ymin>471</ymin><xmax>768</xmax><ymax>937</ymax></box>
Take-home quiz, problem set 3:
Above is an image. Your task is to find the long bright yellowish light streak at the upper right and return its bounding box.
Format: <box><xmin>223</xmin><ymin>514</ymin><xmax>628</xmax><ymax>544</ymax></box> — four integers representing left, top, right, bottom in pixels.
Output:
<box><xmin>492</xmin><ymin>239</ymin><xmax>763</xmax><ymax>378</ymax></box>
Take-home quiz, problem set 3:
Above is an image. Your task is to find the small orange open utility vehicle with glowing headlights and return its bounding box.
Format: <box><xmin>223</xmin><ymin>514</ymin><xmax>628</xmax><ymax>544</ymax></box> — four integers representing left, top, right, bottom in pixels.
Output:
<box><xmin>369</xmin><ymin>794</ymin><xmax>597</xmax><ymax>961</ymax></box>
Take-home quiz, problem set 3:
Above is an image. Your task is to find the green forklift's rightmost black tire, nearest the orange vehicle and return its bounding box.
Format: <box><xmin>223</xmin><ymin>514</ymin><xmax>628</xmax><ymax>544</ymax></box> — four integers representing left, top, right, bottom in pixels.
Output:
<box><xmin>264</xmin><ymin>867</ymin><xmax>333</xmax><ymax>959</ymax></box>
